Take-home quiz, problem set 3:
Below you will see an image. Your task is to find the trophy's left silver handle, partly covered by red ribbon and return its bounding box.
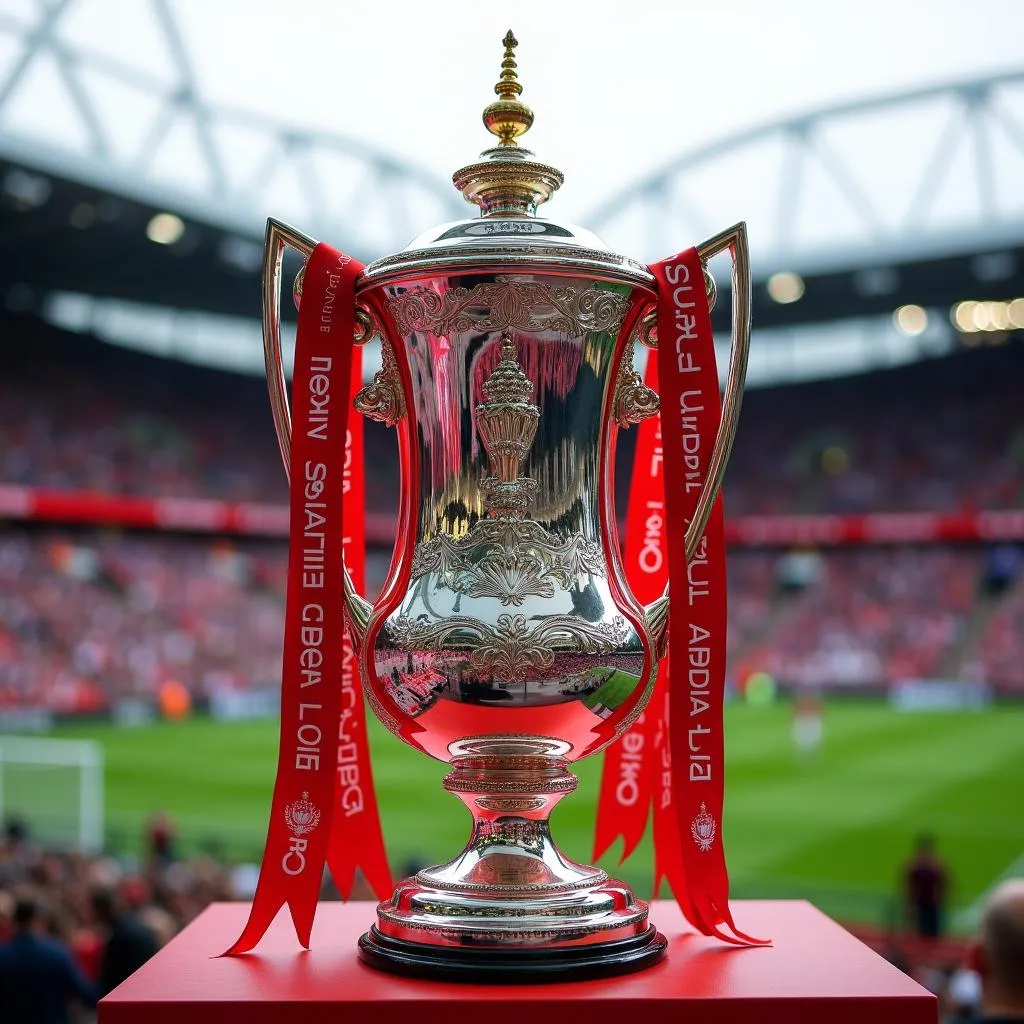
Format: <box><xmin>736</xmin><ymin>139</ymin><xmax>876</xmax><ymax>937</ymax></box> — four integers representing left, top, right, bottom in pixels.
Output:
<box><xmin>263</xmin><ymin>217</ymin><xmax>373</xmax><ymax>642</ymax></box>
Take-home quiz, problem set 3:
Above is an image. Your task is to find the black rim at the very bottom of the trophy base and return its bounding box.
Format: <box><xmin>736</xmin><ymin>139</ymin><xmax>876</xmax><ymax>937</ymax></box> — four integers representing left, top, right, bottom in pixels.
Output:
<box><xmin>359</xmin><ymin>925</ymin><xmax>669</xmax><ymax>985</ymax></box>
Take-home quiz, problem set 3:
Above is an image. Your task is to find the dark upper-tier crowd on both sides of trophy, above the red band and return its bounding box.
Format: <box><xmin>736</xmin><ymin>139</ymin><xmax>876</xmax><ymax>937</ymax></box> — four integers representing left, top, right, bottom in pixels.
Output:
<box><xmin>6</xmin><ymin>319</ymin><xmax>1024</xmax><ymax>515</ymax></box>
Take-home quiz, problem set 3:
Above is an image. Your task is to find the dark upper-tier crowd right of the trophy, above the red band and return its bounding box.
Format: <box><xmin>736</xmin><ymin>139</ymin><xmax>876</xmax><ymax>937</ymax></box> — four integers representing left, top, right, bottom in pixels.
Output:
<box><xmin>726</xmin><ymin>344</ymin><xmax>1024</xmax><ymax>515</ymax></box>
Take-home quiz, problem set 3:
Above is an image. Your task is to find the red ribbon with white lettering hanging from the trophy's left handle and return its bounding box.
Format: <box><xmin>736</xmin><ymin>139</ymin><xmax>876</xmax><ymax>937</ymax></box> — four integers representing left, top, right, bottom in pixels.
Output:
<box><xmin>227</xmin><ymin>244</ymin><xmax>390</xmax><ymax>953</ymax></box>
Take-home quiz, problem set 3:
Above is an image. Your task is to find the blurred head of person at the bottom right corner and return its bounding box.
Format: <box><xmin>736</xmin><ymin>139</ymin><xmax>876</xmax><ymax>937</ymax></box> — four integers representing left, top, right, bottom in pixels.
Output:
<box><xmin>969</xmin><ymin>879</ymin><xmax>1024</xmax><ymax>1024</ymax></box>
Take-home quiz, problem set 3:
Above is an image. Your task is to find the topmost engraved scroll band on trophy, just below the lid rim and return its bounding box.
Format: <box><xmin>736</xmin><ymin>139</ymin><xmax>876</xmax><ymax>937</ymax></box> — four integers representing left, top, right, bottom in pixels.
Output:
<box><xmin>388</xmin><ymin>274</ymin><xmax>629</xmax><ymax>337</ymax></box>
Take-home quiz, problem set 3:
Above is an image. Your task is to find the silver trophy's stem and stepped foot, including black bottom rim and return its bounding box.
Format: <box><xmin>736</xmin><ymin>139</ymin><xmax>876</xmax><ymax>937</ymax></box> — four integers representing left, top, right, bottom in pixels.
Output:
<box><xmin>359</xmin><ymin>755</ymin><xmax>666</xmax><ymax>981</ymax></box>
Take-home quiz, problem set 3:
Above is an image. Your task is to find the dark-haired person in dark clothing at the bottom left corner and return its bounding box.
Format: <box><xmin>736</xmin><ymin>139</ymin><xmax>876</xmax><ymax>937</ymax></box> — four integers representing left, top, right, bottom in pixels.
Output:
<box><xmin>0</xmin><ymin>898</ymin><xmax>96</xmax><ymax>1024</ymax></box>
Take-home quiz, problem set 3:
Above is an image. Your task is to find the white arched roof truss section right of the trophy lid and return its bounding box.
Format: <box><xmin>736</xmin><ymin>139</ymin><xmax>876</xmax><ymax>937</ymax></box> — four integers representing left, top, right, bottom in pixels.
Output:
<box><xmin>588</xmin><ymin>71</ymin><xmax>1024</xmax><ymax>274</ymax></box>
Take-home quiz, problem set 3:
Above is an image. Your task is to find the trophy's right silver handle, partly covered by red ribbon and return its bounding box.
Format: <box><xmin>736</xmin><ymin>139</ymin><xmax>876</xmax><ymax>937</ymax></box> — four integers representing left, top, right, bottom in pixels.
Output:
<box><xmin>645</xmin><ymin>221</ymin><xmax>751</xmax><ymax>653</ymax></box>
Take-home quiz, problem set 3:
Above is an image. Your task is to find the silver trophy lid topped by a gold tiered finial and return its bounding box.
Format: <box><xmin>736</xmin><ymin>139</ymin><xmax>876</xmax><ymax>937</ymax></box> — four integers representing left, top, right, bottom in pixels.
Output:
<box><xmin>362</xmin><ymin>30</ymin><xmax>652</xmax><ymax>285</ymax></box>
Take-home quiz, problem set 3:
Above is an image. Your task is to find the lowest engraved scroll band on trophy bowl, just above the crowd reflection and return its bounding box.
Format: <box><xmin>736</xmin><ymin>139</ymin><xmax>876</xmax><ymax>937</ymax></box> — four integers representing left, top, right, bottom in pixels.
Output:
<box><xmin>390</xmin><ymin>614</ymin><xmax>629</xmax><ymax>682</ymax></box>
